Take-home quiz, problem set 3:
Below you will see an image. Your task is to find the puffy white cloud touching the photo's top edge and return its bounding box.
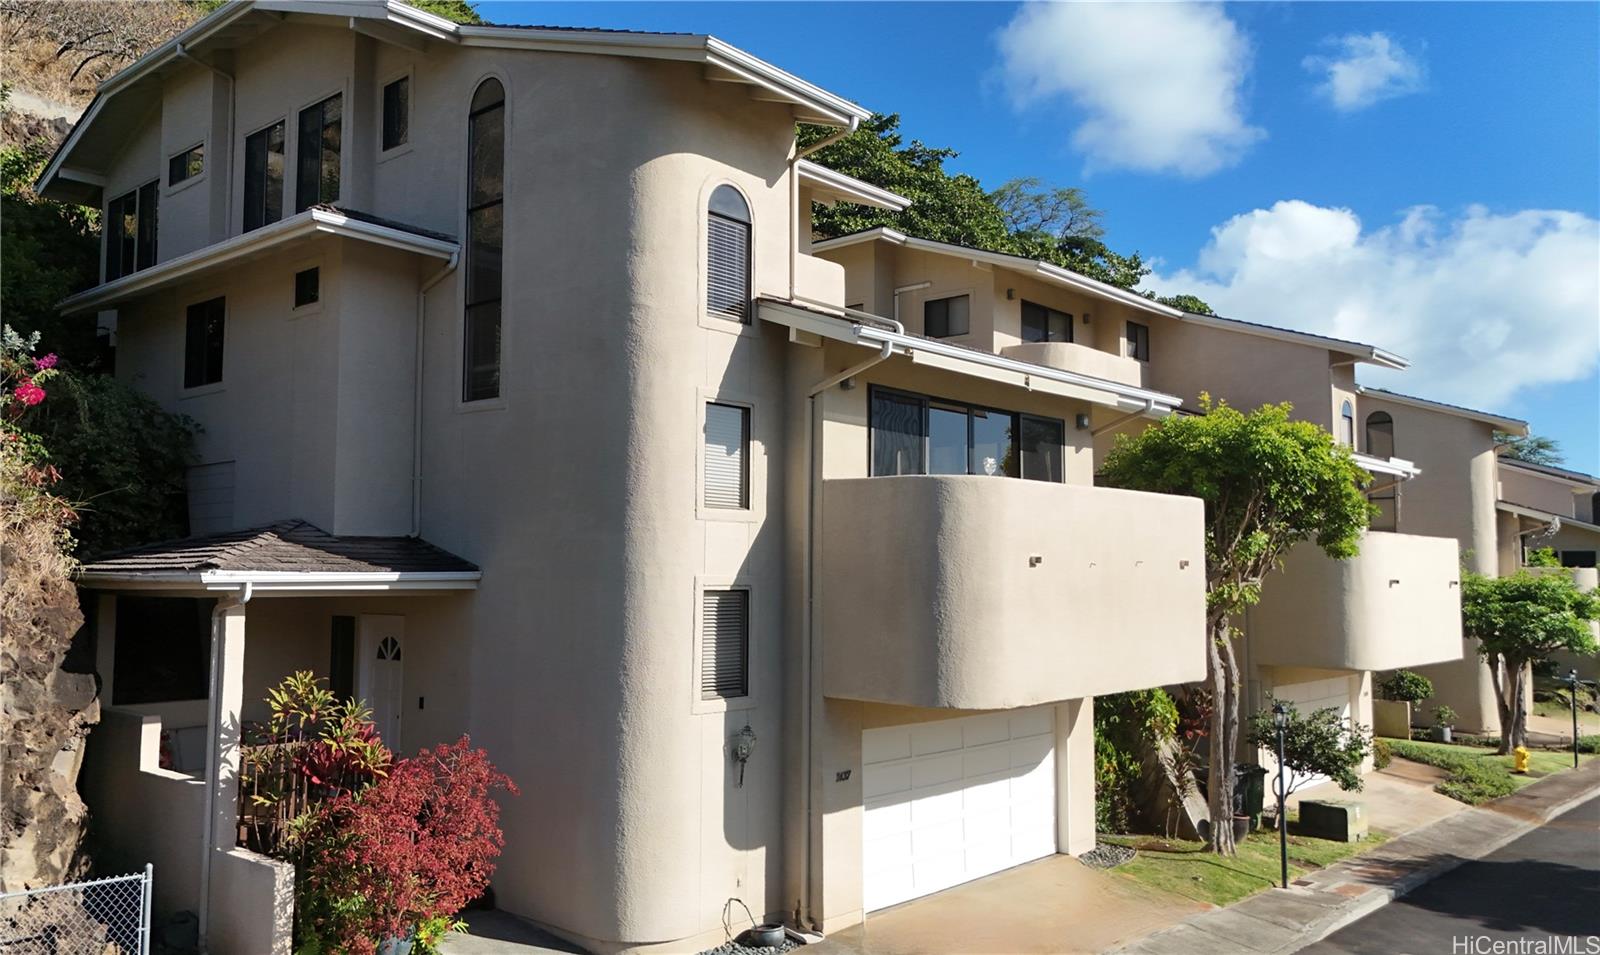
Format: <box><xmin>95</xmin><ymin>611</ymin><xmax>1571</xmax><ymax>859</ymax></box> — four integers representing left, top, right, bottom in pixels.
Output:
<box><xmin>998</xmin><ymin>3</ymin><xmax>1266</xmax><ymax>176</ymax></box>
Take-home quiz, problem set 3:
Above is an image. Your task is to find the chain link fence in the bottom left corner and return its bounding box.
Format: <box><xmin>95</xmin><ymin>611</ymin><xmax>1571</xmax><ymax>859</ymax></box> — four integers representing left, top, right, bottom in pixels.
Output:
<box><xmin>0</xmin><ymin>865</ymin><xmax>152</xmax><ymax>955</ymax></box>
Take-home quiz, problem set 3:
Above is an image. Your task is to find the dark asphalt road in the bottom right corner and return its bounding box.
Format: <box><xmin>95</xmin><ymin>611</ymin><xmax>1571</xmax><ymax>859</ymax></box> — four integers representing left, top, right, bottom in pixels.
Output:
<box><xmin>1302</xmin><ymin>797</ymin><xmax>1600</xmax><ymax>955</ymax></box>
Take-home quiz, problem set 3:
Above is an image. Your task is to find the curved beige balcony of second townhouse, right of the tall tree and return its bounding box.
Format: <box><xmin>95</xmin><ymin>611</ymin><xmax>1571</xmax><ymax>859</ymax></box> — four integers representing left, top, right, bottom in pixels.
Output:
<box><xmin>1248</xmin><ymin>531</ymin><xmax>1461</xmax><ymax>670</ymax></box>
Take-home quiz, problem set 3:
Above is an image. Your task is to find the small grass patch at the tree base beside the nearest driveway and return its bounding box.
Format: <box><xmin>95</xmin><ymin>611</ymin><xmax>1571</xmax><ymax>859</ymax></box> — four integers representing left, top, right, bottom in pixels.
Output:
<box><xmin>1101</xmin><ymin>816</ymin><xmax>1384</xmax><ymax>905</ymax></box>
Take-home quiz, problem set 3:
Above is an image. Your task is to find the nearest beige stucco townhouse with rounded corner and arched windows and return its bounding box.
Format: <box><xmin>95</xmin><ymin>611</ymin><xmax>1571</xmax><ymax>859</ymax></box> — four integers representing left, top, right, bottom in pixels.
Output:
<box><xmin>38</xmin><ymin>0</ymin><xmax>1205</xmax><ymax>953</ymax></box>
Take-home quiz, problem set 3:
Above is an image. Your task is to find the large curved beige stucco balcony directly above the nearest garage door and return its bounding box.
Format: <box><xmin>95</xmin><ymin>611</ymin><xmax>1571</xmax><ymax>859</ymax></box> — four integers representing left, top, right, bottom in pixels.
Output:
<box><xmin>819</xmin><ymin>477</ymin><xmax>1205</xmax><ymax>709</ymax></box>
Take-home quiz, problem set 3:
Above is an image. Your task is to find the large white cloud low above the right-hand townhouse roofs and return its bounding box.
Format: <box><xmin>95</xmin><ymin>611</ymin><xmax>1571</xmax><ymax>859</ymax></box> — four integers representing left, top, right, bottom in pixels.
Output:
<box><xmin>1146</xmin><ymin>200</ymin><xmax>1600</xmax><ymax>410</ymax></box>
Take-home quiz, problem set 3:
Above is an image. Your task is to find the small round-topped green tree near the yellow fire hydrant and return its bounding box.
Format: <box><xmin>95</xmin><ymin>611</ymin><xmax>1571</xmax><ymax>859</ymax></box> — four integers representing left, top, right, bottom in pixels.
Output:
<box><xmin>1461</xmin><ymin>571</ymin><xmax>1600</xmax><ymax>753</ymax></box>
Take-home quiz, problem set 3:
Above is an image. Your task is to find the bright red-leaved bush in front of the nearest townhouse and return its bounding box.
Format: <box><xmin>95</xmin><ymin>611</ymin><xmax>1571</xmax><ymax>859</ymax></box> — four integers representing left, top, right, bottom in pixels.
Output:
<box><xmin>296</xmin><ymin>736</ymin><xmax>518</xmax><ymax>955</ymax></box>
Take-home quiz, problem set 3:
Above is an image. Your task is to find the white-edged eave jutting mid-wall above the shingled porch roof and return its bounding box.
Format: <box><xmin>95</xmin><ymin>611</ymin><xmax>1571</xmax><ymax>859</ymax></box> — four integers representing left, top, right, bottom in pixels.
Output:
<box><xmin>56</xmin><ymin>210</ymin><xmax>461</xmax><ymax>315</ymax></box>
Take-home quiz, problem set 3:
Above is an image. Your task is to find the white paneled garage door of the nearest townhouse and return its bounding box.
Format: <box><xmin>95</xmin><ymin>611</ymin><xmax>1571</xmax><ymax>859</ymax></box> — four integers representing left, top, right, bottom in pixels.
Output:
<box><xmin>861</xmin><ymin>707</ymin><xmax>1056</xmax><ymax>912</ymax></box>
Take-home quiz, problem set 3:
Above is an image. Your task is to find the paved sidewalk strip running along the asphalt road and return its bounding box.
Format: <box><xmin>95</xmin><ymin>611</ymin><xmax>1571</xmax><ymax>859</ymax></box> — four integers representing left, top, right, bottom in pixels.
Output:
<box><xmin>1115</xmin><ymin>760</ymin><xmax>1600</xmax><ymax>955</ymax></box>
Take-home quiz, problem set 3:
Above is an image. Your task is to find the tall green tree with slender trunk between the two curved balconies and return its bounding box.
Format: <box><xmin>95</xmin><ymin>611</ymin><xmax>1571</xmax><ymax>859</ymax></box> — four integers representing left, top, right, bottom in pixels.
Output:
<box><xmin>1101</xmin><ymin>395</ymin><xmax>1371</xmax><ymax>854</ymax></box>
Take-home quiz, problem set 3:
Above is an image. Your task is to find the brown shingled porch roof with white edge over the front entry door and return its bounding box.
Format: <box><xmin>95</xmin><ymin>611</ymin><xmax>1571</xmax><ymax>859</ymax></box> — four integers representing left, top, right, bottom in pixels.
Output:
<box><xmin>78</xmin><ymin>520</ymin><xmax>483</xmax><ymax>593</ymax></box>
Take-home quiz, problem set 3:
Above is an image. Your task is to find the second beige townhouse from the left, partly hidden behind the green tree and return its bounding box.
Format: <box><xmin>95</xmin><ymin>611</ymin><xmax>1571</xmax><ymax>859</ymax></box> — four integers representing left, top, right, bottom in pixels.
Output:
<box><xmin>813</xmin><ymin>229</ymin><xmax>1462</xmax><ymax>774</ymax></box>
